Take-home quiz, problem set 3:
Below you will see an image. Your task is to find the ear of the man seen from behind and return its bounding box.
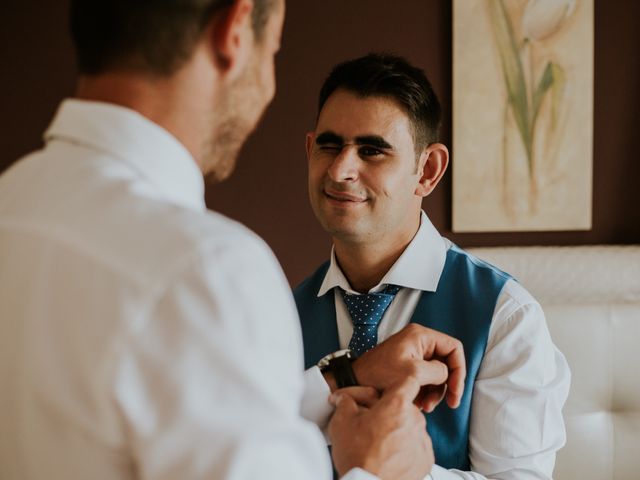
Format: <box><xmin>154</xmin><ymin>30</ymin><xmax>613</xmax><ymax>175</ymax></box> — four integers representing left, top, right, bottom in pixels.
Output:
<box><xmin>207</xmin><ymin>0</ymin><xmax>255</xmax><ymax>78</ymax></box>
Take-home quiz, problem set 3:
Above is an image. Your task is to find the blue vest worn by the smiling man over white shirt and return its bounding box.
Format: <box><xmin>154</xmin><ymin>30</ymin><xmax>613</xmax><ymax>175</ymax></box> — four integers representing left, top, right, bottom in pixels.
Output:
<box><xmin>294</xmin><ymin>245</ymin><xmax>511</xmax><ymax>470</ymax></box>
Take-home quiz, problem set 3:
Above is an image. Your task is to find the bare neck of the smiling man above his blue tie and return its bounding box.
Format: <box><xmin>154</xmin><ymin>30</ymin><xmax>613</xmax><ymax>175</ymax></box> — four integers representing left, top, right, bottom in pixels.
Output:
<box><xmin>334</xmin><ymin>228</ymin><xmax>418</xmax><ymax>293</ymax></box>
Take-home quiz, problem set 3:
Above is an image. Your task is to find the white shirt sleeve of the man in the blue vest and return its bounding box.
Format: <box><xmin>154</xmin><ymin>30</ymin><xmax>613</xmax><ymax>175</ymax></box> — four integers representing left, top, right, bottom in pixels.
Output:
<box><xmin>431</xmin><ymin>280</ymin><xmax>571</xmax><ymax>480</ymax></box>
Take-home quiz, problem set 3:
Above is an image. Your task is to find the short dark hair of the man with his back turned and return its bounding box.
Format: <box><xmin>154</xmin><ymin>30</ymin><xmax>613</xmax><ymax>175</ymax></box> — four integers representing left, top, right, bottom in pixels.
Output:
<box><xmin>70</xmin><ymin>0</ymin><xmax>275</xmax><ymax>75</ymax></box>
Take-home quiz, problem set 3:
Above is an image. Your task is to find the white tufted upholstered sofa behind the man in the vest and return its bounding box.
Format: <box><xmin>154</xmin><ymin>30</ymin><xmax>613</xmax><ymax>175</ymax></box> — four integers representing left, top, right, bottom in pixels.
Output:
<box><xmin>469</xmin><ymin>245</ymin><xmax>640</xmax><ymax>480</ymax></box>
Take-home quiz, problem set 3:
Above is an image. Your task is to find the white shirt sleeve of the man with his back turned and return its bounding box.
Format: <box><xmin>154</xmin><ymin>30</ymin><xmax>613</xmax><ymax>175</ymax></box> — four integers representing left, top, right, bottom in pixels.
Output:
<box><xmin>114</xmin><ymin>231</ymin><xmax>336</xmax><ymax>480</ymax></box>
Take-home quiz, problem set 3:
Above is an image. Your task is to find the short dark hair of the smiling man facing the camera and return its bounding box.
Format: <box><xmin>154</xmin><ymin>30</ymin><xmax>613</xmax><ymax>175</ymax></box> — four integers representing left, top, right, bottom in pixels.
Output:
<box><xmin>318</xmin><ymin>53</ymin><xmax>442</xmax><ymax>154</ymax></box>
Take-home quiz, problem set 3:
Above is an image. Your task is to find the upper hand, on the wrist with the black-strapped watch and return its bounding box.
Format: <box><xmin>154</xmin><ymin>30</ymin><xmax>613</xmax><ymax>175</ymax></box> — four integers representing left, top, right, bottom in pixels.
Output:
<box><xmin>350</xmin><ymin>323</ymin><xmax>466</xmax><ymax>412</ymax></box>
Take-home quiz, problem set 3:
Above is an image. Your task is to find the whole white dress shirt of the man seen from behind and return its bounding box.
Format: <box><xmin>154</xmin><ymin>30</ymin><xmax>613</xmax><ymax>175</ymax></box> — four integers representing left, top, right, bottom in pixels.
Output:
<box><xmin>0</xmin><ymin>100</ymin><xmax>375</xmax><ymax>480</ymax></box>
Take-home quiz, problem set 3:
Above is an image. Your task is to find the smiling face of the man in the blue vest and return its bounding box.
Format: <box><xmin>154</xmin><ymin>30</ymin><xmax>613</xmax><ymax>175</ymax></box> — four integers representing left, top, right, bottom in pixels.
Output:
<box><xmin>307</xmin><ymin>89</ymin><xmax>422</xmax><ymax>243</ymax></box>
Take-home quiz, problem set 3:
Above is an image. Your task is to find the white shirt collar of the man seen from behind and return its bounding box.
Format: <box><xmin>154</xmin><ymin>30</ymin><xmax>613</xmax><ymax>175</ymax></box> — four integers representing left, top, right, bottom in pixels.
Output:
<box><xmin>44</xmin><ymin>99</ymin><xmax>206</xmax><ymax>210</ymax></box>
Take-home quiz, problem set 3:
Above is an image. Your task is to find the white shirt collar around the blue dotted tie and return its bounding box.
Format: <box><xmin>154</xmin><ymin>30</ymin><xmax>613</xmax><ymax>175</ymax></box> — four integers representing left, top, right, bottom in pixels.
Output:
<box><xmin>318</xmin><ymin>211</ymin><xmax>450</xmax><ymax>297</ymax></box>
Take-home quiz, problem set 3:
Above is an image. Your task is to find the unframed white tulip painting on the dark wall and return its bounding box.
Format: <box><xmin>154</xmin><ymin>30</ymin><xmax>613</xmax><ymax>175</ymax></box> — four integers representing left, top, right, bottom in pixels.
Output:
<box><xmin>452</xmin><ymin>0</ymin><xmax>593</xmax><ymax>232</ymax></box>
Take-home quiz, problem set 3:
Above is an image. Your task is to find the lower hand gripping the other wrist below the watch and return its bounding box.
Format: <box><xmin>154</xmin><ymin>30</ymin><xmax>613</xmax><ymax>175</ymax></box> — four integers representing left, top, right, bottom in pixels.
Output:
<box><xmin>329</xmin><ymin>379</ymin><xmax>434</xmax><ymax>480</ymax></box>
